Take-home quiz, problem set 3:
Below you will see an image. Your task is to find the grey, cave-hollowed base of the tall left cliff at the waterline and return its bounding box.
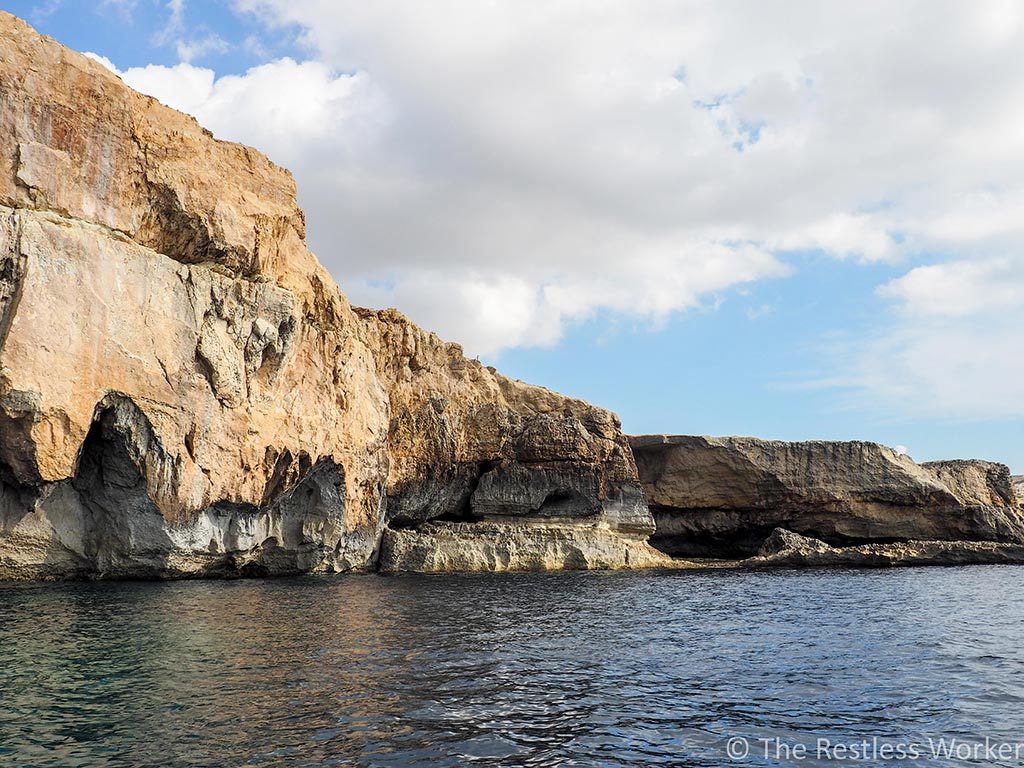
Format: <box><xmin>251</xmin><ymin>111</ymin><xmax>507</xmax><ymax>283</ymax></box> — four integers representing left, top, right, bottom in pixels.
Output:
<box><xmin>0</xmin><ymin>393</ymin><xmax>354</xmax><ymax>579</ymax></box>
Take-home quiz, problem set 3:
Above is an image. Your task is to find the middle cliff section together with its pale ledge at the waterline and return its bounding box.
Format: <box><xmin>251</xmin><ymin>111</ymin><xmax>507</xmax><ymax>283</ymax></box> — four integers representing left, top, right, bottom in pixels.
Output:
<box><xmin>356</xmin><ymin>309</ymin><xmax>665</xmax><ymax>571</ymax></box>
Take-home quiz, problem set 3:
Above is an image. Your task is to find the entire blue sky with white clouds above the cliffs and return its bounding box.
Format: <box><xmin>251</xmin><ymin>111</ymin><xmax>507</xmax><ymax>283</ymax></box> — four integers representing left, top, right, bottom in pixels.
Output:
<box><xmin>0</xmin><ymin>0</ymin><xmax>1024</xmax><ymax>473</ymax></box>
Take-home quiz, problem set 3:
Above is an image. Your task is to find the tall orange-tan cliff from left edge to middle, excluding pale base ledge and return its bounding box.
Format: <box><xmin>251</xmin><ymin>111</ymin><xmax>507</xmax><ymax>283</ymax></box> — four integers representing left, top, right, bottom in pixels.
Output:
<box><xmin>0</xmin><ymin>12</ymin><xmax>653</xmax><ymax>578</ymax></box>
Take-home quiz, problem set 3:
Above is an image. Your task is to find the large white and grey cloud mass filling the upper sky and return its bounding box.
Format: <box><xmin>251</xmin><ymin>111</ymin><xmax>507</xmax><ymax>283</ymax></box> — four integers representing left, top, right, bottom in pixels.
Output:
<box><xmin>114</xmin><ymin>0</ymin><xmax>1024</xmax><ymax>380</ymax></box>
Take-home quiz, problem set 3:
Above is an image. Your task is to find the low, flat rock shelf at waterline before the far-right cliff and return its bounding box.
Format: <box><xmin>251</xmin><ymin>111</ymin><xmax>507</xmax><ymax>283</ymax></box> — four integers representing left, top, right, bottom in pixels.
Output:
<box><xmin>739</xmin><ymin>528</ymin><xmax>1024</xmax><ymax>568</ymax></box>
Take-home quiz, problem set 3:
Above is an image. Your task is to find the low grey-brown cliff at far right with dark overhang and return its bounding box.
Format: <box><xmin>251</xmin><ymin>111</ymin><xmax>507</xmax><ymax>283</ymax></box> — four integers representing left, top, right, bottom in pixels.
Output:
<box><xmin>631</xmin><ymin>435</ymin><xmax>1024</xmax><ymax>557</ymax></box>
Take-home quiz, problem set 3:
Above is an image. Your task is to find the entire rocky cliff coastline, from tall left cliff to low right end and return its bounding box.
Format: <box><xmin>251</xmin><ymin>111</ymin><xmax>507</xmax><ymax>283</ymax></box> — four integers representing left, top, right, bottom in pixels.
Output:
<box><xmin>0</xmin><ymin>12</ymin><xmax>1024</xmax><ymax>579</ymax></box>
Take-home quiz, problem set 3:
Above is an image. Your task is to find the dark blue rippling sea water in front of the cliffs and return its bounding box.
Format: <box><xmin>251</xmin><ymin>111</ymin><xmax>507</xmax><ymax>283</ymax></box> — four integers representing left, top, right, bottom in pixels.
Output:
<box><xmin>0</xmin><ymin>567</ymin><xmax>1024</xmax><ymax>766</ymax></box>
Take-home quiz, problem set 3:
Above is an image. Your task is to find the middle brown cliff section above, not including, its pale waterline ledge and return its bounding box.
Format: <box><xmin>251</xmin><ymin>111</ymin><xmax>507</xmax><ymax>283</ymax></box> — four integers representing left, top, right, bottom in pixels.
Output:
<box><xmin>356</xmin><ymin>309</ymin><xmax>653</xmax><ymax>536</ymax></box>
